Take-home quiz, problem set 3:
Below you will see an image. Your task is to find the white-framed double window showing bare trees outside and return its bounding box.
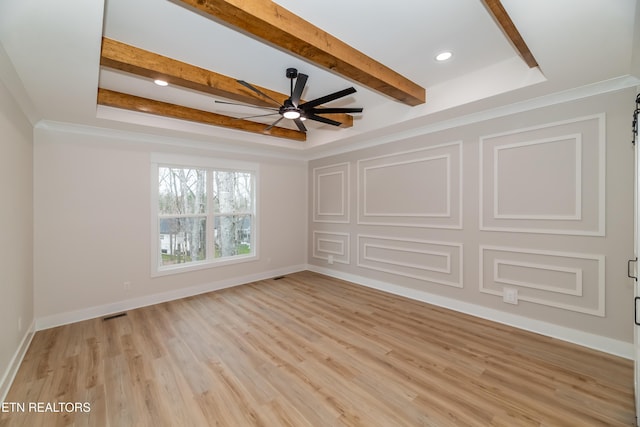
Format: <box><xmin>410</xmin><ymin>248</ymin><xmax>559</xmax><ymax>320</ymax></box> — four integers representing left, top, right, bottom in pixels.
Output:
<box><xmin>152</xmin><ymin>154</ymin><xmax>257</xmax><ymax>274</ymax></box>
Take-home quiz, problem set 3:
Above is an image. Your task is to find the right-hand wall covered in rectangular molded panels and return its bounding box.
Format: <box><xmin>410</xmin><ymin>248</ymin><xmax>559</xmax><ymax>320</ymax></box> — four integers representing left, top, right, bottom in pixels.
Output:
<box><xmin>308</xmin><ymin>89</ymin><xmax>635</xmax><ymax>357</ymax></box>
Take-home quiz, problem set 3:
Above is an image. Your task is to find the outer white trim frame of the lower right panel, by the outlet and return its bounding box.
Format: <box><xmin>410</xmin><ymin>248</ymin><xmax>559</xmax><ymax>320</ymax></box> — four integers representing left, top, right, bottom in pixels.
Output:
<box><xmin>478</xmin><ymin>245</ymin><xmax>605</xmax><ymax>317</ymax></box>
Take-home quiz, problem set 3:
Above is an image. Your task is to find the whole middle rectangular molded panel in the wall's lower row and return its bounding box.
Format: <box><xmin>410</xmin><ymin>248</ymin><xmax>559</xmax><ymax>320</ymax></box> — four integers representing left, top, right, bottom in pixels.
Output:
<box><xmin>357</xmin><ymin>234</ymin><xmax>463</xmax><ymax>288</ymax></box>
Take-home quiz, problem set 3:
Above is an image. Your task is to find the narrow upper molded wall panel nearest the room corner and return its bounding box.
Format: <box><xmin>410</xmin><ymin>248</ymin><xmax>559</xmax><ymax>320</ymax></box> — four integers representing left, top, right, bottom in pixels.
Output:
<box><xmin>313</xmin><ymin>163</ymin><xmax>351</xmax><ymax>223</ymax></box>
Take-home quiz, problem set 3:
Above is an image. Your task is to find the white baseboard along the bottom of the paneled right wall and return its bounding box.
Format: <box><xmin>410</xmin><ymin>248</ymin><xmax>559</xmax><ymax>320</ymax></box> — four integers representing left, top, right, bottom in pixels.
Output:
<box><xmin>307</xmin><ymin>265</ymin><xmax>635</xmax><ymax>360</ymax></box>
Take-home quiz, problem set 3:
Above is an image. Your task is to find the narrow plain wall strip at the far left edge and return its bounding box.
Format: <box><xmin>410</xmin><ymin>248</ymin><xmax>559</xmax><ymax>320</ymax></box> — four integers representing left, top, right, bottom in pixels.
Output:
<box><xmin>0</xmin><ymin>69</ymin><xmax>33</xmax><ymax>401</ymax></box>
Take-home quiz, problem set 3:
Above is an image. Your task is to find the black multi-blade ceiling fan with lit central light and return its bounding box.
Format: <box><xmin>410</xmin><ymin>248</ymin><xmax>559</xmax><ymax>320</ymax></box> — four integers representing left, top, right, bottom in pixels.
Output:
<box><xmin>216</xmin><ymin>68</ymin><xmax>362</xmax><ymax>132</ymax></box>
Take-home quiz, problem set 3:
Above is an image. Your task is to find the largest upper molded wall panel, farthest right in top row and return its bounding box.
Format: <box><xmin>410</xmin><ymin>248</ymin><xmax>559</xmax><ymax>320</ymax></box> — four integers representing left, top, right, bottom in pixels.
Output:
<box><xmin>480</xmin><ymin>114</ymin><xmax>606</xmax><ymax>236</ymax></box>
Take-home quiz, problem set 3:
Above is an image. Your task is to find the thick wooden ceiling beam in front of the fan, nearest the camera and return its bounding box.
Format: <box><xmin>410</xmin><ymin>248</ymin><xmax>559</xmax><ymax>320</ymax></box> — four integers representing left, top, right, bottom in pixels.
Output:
<box><xmin>174</xmin><ymin>0</ymin><xmax>426</xmax><ymax>106</ymax></box>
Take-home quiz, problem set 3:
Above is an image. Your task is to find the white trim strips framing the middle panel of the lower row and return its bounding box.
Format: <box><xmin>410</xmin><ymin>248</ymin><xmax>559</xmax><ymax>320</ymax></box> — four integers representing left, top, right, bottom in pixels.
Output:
<box><xmin>356</xmin><ymin>234</ymin><xmax>464</xmax><ymax>288</ymax></box>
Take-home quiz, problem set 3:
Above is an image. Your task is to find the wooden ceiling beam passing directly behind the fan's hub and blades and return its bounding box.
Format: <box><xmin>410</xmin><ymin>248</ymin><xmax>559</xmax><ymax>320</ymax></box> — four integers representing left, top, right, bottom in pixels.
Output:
<box><xmin>100</xmin><ymin>37</ymin><xmax>353</xmax><ymax>128</ymax></box>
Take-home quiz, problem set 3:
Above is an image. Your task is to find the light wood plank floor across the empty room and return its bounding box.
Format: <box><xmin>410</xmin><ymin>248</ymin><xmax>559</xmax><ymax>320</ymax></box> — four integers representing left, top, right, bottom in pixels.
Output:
<box><xmin>0</xmin><ymin>272</ymin><xmax>634</xmax><ymax>427</ymax></box>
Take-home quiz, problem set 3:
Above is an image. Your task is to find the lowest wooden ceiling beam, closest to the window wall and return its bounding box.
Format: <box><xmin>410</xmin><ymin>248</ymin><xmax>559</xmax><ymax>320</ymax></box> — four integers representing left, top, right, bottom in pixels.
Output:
<box><xmin>98</xmin><ymin>88</ymin><xmax>307</xmax><ymax>141</ymax></box>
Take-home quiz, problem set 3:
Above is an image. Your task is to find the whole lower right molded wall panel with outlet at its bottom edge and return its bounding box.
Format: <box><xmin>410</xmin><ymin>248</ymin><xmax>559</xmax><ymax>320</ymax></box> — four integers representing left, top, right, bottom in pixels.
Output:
<box><xmin>480</xmin><ymin>246</ymin><xmax>605</xmax><ymax>317</ymax></box>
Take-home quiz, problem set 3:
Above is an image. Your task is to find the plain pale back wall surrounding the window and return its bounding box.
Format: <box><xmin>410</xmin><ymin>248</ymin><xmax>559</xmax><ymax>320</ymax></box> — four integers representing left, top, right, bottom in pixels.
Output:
<box><xmin>34</xmin><ymin>127</ymin><xmax>307</xmax><ymax>329</ymax></box>
